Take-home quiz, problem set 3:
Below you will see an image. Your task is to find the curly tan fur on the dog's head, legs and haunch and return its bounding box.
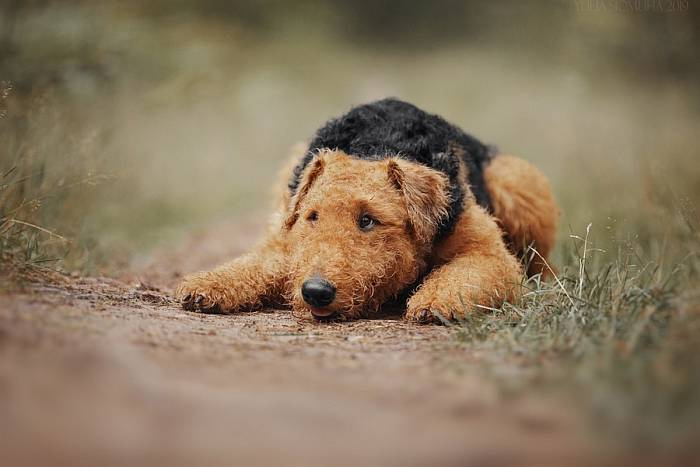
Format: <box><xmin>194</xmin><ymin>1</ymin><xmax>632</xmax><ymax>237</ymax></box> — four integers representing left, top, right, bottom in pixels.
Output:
<box><xmin>176</xmin><ymin>150</ymin><xmax>556</xmax><ymax>322</ymax></box>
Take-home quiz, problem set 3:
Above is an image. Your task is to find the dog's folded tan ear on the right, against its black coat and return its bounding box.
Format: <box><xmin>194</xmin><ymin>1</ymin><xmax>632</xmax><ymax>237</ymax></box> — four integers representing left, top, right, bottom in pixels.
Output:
<box><xmin>387</xmin><ymin>157</ymin><xmax>450</xmax><ymax>243</ymax></box>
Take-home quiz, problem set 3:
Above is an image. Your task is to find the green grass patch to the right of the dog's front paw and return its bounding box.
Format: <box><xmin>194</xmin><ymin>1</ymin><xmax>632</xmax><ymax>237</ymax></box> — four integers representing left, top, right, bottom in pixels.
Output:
<box><xmin>457</xmin><ymin>218</ymin><xmax>700</xmax><ymax>453</ymax></box>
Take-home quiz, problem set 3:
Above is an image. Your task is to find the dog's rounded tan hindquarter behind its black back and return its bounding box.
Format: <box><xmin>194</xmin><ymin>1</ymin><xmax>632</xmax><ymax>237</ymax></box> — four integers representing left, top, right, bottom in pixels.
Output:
<box><xmin>484</xmin><ymin>155</ymin><xmax>559</xmax><ymax>276</ymax></box>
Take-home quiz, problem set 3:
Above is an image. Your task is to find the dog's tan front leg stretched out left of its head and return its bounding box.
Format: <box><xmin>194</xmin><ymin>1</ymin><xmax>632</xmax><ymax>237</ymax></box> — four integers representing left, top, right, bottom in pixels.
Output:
<box><xmin>176</xmin><ymin>234</ymin><xmax>288</xmax><ymax>313</ymax></box>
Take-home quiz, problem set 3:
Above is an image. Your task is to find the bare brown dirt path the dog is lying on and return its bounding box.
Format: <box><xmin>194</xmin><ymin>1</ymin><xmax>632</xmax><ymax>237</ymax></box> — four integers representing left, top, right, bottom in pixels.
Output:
<box><xmin>0</xmin><ymin>223</ymin><xmax>608</xmax><ymax>466</ymax></box>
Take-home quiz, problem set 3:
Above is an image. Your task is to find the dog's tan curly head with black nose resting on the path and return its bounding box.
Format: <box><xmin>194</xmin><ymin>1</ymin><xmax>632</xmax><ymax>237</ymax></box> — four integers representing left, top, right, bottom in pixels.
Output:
<box><xmin>283</xmin><ymin>151</ymin><xmax>449</xmax><ymax>318</ymax></box>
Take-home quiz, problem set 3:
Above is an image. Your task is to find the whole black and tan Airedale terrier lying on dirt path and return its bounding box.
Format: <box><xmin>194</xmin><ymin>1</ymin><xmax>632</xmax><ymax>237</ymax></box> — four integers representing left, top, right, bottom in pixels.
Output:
<box><xmin>177</xmin><ymin>99</ymin><xmax>558</xmax><ymax>322</ymax></box>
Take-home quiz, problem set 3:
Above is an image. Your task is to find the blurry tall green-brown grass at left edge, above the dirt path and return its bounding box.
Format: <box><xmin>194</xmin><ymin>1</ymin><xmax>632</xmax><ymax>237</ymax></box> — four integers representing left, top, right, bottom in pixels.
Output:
<box><xmin>0</xmin><ymin>81</ymin><xmax>110</xmax><ymax>274</ymax></box>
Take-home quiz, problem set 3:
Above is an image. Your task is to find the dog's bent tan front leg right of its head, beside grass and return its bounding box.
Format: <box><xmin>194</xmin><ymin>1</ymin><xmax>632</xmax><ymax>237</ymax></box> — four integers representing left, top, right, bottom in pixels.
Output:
<box><xmin>406</xmin><ymin>204</ymin><xmax>522</xmax><ymax>322</ymax></box>
